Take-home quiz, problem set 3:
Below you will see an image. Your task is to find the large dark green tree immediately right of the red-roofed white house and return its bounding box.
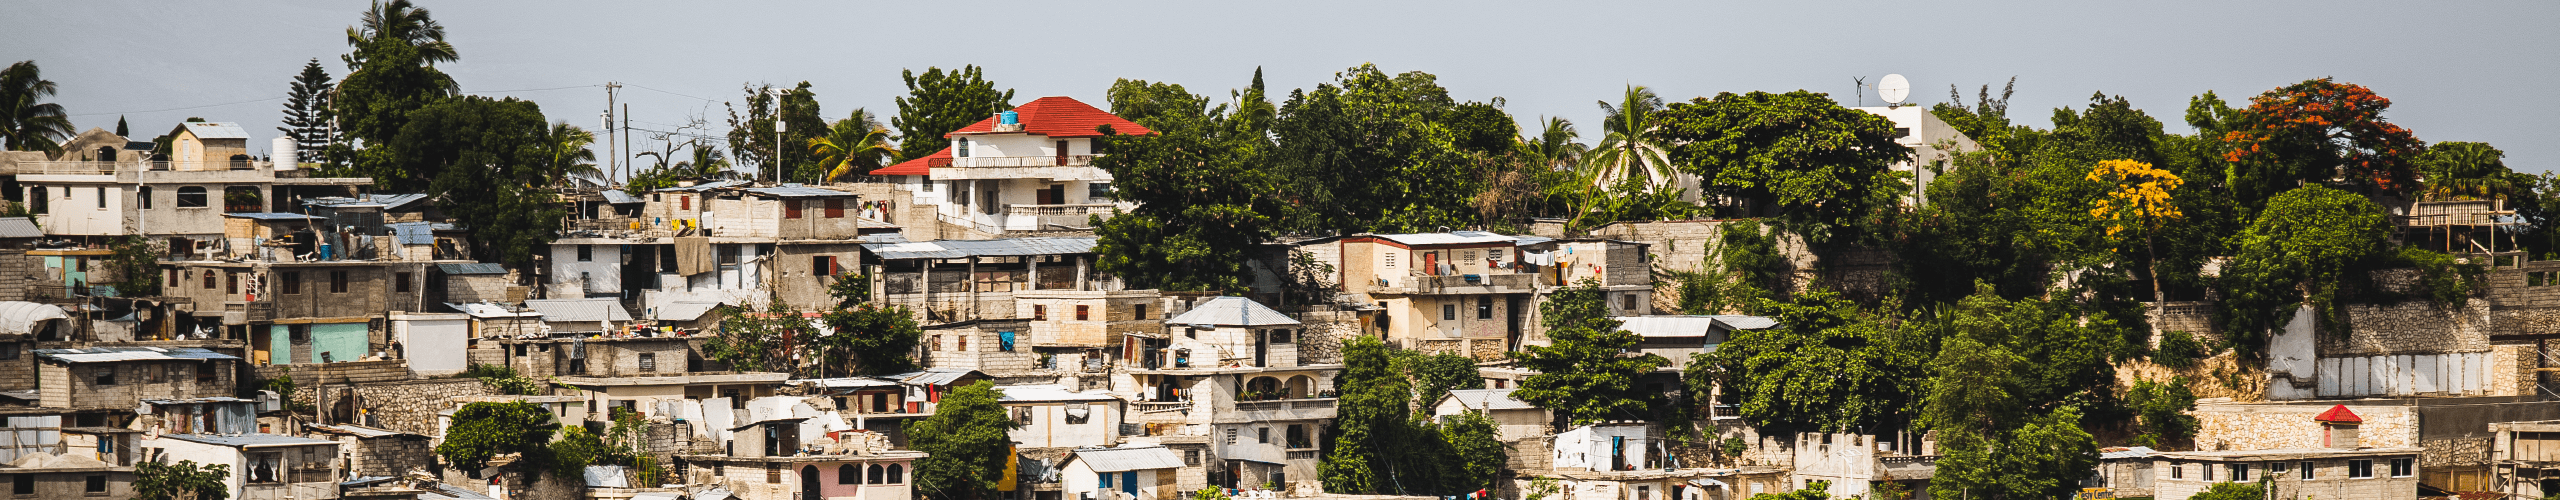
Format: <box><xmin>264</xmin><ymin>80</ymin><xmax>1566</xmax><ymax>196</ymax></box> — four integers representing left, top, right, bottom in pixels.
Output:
<box><xmin>1093</xmin><ymin>79</ymin><xmax>1288</xmax><ymax>292</ymax></box>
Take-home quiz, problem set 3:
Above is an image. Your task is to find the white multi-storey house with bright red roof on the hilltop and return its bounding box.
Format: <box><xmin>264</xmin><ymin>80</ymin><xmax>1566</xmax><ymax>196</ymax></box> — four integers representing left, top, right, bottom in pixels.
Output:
<box><xmin>873</xmin><ymin>95</ymin><xmax>1155</xmax><ymax>236</ymax></box>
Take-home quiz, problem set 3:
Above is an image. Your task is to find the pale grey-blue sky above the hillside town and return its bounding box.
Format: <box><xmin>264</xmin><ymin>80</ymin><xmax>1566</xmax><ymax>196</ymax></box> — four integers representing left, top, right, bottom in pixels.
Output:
<box><xmin>15</xmin><ymin>0</ymin><xmax>2560</xmax><ymax>172</ymax></box>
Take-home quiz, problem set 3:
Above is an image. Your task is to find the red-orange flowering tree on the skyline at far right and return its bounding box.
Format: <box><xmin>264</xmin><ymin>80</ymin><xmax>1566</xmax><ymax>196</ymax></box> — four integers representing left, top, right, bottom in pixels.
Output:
<box><xmin>2222</xmin><ymin>79</ymin><xmax>2427</xmax><ymax>208</ymax></box>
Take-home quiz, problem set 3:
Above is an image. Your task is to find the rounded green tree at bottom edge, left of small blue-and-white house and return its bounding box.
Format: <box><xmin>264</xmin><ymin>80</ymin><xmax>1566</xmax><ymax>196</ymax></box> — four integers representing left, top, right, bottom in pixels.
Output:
<box><xmin>906</xmin><ymin>379</ymin><xmax>1019</xmax><ymax>500</ymax></box>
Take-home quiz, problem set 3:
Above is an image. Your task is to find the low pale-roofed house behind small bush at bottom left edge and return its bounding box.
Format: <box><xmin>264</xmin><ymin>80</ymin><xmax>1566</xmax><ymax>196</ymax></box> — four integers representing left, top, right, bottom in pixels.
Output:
<box><xmin>143</xmin><ymin>433</ymin><xmax>346</xmax><ymax>500</ymax></box>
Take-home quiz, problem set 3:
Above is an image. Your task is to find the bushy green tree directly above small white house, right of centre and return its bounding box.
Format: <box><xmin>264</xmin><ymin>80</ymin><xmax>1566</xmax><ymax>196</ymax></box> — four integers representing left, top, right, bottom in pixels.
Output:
<box><xmin>1510</xmin><ymin>279</ymin><xmax>1672</xmax><ymax>426</ymax></box>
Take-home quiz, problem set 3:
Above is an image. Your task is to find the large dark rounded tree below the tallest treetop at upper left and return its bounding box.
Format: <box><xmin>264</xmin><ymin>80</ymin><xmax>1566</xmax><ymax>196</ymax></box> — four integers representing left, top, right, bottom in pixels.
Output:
<box><xmin>394</xmin><ymin>95</ymin><xmax>565</xmax><ymax>267</ymax></box>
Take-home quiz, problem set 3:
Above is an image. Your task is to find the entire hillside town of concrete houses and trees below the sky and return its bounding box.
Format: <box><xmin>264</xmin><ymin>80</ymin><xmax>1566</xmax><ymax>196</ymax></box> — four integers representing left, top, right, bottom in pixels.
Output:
<box><xmin>0</xmin><ymin>0</ymin><xmax>2560</xmax><ymax>500</ymax></box>
